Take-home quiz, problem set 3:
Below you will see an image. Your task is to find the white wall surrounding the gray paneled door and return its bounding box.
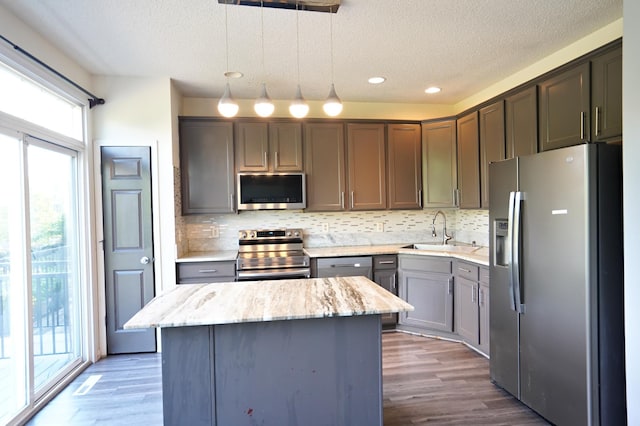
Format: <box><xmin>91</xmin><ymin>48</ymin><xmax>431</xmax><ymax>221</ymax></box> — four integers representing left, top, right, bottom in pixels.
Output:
<box><xmin>92</xmin><ymin>76</ymin><xmax>178</xmax><ymax>356</ymax></box>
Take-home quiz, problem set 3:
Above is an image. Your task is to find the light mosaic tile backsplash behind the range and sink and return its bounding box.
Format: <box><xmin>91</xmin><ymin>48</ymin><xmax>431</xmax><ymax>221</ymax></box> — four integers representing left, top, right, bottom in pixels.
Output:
<box><xmin>176</xmin><ymin>207</ymin><xmax>489</xmax><ymax>256</ymax></box>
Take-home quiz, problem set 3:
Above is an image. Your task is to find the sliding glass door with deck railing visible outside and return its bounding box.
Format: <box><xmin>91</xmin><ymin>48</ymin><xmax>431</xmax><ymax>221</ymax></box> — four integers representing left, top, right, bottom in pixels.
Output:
<box><xmin>0</xmin><ymin>132</ymin><xmax>83</xmax><ymax>424</ymax></box>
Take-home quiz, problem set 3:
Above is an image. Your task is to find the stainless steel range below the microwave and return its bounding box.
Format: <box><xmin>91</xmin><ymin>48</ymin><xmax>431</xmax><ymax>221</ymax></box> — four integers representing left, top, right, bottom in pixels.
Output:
<box><xmin>236</xmin><ymin>229</ymin><xmax>311</xmax><ymax>281</ymax></box>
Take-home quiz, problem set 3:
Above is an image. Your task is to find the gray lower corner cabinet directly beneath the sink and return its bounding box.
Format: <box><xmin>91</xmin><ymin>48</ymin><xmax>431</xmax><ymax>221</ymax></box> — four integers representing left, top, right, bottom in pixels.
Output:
<box><xmin>398</xmin><ymin>254</ymin><xmax>453</xmax><ymax>333</ymax></box>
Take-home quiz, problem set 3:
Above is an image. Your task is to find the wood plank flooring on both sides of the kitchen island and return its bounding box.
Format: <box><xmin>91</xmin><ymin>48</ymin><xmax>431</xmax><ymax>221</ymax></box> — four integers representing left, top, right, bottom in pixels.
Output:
<box><xmin>27</xmin><ymin>332</ymin><xmax>548</xmax><ymax>426</ymax></box>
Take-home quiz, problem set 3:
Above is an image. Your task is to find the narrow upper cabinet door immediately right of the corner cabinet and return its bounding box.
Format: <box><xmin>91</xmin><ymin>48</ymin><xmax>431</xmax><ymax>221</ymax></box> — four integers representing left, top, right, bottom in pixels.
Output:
<box><xmin>457</xmin><ymin>111</ymin><xmax>480</xmax><ymax>209</ymax></box>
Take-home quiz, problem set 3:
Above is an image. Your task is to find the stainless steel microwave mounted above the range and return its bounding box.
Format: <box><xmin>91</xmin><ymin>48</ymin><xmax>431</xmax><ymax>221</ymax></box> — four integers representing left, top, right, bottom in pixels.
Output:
<box><xmin>237</xmin><ymin>173</ymin><xmax>307</xmax><ymax>210</ymax></box>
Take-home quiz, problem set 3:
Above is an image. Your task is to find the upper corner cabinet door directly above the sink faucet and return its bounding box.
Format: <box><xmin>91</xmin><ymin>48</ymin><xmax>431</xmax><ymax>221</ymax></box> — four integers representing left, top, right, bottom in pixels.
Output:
<box><xmin>422</xmin><ymin>120</ymin><xmax>458</xmax><ymax>207</ymax></box>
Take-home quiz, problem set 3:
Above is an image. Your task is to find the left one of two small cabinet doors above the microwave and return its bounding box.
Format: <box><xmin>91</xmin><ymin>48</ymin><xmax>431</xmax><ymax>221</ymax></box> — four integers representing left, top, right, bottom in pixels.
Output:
<box><xmin>235</xmin><ymin>122</ymin><xmax>269</xmax><ymax>172</ymax></box>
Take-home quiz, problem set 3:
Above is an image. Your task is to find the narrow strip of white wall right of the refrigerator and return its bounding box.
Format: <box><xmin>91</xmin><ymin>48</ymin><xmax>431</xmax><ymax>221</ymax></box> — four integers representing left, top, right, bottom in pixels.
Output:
<box><xmin>622</xmin><ymin>0</ymin><xmax>640</xmax><ymax>425</ymax></box>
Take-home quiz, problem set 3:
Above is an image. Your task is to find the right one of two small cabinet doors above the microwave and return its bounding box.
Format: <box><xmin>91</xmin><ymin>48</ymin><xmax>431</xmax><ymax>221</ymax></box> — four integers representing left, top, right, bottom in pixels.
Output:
<box><xmin>269</xmin><ymin>123</ymin><xmax>302</xmax><ymax>172</ymax></box>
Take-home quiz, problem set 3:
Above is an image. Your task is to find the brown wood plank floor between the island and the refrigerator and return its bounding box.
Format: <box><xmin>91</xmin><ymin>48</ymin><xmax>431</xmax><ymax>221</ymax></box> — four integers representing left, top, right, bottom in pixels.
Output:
<box><xmin>382</xmin><ymin>333</ymin><xmax>548</xmax><ymax>426</ymax></box>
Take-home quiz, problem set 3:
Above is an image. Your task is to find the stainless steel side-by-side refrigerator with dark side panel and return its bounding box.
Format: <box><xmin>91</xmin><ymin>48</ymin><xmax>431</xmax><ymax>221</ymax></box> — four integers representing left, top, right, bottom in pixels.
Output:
<box><xmin>489</xmin><ymin>144</ymin><xmax>626</xmax><ymax>425</ymax></box>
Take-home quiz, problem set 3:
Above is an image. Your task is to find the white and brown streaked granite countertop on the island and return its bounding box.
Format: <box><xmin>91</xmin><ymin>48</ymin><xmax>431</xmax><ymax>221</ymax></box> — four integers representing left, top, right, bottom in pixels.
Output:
<box><xmin>124</xmin><ymin>277</ymin><xmax>413</xmax><ymax>329</ymax></box>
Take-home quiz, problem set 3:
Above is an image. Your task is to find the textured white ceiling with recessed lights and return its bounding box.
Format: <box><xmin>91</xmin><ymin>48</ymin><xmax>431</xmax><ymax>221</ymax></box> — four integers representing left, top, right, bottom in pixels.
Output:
<box><xmin>0</xmin><ymin>0</ymin><xmax>622</xmax><ymax>104</ymax></box>
